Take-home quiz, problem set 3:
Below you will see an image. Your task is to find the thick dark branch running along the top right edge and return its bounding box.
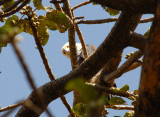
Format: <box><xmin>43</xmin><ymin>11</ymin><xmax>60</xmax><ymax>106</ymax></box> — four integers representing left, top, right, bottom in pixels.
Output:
<box><xmin>90</xmin><ymin>0</ymin><xmax>156</xmax><ymax>14</ymax></box>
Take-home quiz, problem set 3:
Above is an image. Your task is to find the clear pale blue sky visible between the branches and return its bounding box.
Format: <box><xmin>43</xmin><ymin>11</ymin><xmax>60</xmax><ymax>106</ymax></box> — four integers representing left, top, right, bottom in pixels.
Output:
<box><xmin>0</xmin><ymin>0</ymin><xmax>151</xmax><ymax>117</ymax></box>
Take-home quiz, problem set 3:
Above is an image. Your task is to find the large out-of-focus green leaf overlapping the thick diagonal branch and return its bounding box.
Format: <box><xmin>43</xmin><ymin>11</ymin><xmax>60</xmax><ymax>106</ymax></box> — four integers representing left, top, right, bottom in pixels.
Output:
<box><xmin>66</xmin><ymin>78</ymin><xmax>98</xmax><ymax>103</ymax></box>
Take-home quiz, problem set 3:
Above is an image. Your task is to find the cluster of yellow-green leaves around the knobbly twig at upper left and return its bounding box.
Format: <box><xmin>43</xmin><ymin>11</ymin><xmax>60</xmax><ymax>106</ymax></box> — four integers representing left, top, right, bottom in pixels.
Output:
<box><xmin>0</xmin><ymin>4</ymin><xmax>69</xmax><ymax>47</ymax></box>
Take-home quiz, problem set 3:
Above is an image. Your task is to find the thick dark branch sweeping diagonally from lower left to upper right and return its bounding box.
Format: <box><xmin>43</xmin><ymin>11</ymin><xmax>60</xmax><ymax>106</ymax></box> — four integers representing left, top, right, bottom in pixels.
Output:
<box><xmin>17</xmin><ymin>13</ymin><xmax>141</xmax><ymax>117</ymax></box>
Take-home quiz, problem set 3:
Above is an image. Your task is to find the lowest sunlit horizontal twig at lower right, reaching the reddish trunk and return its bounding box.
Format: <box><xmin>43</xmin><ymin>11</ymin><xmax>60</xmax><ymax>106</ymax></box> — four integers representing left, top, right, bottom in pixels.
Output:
<box><xmin>104</xmin><ymin>105</ymin><xmax>134</xmax><ymax>110</ymax></box>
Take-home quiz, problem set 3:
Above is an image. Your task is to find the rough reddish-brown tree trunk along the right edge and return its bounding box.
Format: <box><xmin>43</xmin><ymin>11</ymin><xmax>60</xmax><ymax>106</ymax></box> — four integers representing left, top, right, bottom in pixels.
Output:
<box><xmin>135</xmin><ymin>0</ymin><xmax>160</xmax><ymax>117</ymax></box>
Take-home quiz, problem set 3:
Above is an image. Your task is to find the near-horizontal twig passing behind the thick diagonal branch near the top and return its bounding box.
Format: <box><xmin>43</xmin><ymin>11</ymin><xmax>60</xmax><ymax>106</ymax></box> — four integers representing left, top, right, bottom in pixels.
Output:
<box><xmin>76</xmin><ymin>17</ymin><xmax>153</xmax><ymax>24</ymax></box>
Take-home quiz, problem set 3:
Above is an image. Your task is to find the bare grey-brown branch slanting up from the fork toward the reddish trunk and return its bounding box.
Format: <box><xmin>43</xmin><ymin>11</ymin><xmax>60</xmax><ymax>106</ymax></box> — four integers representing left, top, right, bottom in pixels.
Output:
<box><xmin>103</xmin><ymin>50</ymin><xmax>143</xmax><ymax>82</ymax></box>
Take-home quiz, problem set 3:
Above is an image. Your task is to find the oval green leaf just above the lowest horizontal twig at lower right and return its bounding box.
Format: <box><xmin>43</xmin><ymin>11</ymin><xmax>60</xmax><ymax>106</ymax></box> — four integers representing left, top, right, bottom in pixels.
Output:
<box><xmin>109</xmin><ymin>97</ymin><xmax>125</xmax><ymax>105</ymax></box>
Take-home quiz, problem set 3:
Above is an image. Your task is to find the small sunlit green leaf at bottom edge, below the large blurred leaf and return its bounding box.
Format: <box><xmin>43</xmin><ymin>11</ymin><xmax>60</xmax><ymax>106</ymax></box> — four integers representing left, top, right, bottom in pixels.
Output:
<box><xmin>72</xmin><ymin>103</ymin><xmax>87</xmax><ymax>117</ymax></box>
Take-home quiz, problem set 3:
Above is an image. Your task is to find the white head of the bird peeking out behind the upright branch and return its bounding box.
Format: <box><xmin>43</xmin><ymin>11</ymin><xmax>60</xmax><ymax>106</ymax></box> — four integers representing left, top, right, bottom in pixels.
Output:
<box><xmin>62</xmin><ymin>42</ymin><xmax>82</xmax><ymax>58</ymax></box>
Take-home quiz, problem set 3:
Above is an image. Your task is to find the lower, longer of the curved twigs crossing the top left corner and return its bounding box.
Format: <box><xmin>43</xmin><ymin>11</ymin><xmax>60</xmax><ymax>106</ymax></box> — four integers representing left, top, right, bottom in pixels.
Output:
<box><xmin>0</xmin><ymin>0</ymin><xmax>30</xmax><ymax>18</ymax></box>
